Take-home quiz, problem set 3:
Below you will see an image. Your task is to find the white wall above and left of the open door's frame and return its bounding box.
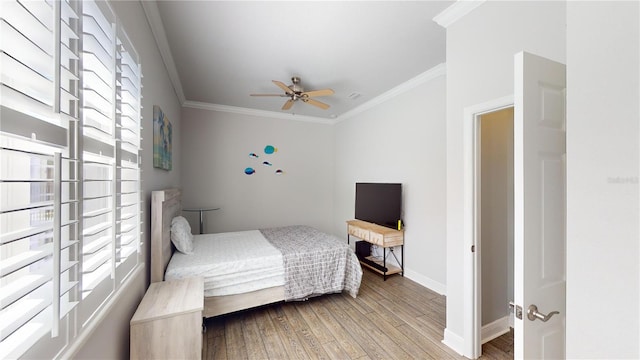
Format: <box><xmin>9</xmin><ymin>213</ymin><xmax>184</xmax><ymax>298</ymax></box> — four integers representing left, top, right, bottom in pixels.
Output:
<box><xmin>445</xmin><ymin>1</ymin><xmax>566</xmax><ymax>351</ymax></box>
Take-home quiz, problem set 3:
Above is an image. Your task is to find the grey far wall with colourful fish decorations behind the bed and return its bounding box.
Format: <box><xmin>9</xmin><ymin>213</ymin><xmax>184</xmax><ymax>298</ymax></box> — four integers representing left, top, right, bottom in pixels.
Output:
<box><xmin>181</xmin><ymin>104</ymin><xmax>333</xmax><ymax>232</ymax></box>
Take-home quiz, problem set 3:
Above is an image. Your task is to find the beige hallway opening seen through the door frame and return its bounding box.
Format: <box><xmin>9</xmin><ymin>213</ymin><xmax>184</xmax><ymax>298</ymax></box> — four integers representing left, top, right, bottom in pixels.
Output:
<box><xmin>476</xmin><ymin>106</ymin><xmax>514</xmax><ymax>355</ymax></box>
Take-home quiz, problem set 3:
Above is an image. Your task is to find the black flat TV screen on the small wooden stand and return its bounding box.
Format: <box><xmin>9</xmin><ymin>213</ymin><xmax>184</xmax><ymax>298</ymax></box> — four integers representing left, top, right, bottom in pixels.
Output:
<box><xmin>355</xmin><ymin>183</ymin><xmax>402</xmax><ymax>229</ymax></box>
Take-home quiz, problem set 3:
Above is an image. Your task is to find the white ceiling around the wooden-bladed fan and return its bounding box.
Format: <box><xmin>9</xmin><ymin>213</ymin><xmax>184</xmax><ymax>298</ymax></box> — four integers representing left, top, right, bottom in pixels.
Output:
<box><xmin>142</xmin><ymin>1</ymin><xmax>454</xmax><ymax>119</ymax></box>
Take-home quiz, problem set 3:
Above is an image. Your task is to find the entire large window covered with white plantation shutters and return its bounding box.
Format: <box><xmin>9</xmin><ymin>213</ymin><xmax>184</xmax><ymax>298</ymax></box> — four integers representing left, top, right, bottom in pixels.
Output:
<box><xmin>0</xmin><ymin>0</ymin><xmax>142</xmax><ymax>358</ymax></box>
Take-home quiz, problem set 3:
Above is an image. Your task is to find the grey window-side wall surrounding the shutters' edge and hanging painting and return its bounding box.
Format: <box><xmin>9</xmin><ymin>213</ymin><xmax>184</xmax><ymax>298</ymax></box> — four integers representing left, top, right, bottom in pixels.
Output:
<box><xmin>74</xmin><ymin>1</ymin><xmax>181</xmax><ymax>359</ymax></box>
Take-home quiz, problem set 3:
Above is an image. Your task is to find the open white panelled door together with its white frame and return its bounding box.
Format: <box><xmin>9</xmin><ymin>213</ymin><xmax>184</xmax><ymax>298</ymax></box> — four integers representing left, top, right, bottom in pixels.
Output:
<box><xmin>462</xmin><ymin>52</ymin><xmax>566</xmax><ymax>359</ymax></box>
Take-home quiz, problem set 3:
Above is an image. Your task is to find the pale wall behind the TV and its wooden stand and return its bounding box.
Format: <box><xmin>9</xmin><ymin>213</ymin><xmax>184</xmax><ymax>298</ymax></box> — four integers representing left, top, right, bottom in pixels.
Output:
<box><xmin>333</xmin><ymin>72</ymin><xmax>446</xmax><ymax>293</ymax></box>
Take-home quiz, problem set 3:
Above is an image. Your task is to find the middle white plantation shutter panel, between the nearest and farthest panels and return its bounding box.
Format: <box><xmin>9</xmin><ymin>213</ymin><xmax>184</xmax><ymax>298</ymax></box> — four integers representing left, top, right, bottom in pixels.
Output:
<box><xmin>80</xmin><ymin>1</ymin><xmax>116</xmax><ymax>321</ymax></box>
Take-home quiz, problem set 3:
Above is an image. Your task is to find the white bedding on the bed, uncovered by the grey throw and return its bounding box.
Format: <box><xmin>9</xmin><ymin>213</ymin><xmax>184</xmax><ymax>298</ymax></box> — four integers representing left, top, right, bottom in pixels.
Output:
<box><xmin>165</xmin><ymin>230</ymin><xmax>284</xmax><ymax>296</ymax></box>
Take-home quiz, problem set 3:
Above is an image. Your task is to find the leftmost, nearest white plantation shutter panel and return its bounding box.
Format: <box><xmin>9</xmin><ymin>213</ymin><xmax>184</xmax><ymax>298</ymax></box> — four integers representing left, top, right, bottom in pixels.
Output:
<box><xmin>0</xmin><ymin>1</ymin><xmax>78</xmax><ymax>358</ymax></box>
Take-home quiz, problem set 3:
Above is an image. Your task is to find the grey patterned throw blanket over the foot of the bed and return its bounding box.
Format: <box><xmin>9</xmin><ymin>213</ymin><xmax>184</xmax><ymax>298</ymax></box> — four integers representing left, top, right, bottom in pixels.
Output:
<box><xmin>260</xmin><ymin>226</ymin><xmax>362</xmax><ymax>301</ymax></box>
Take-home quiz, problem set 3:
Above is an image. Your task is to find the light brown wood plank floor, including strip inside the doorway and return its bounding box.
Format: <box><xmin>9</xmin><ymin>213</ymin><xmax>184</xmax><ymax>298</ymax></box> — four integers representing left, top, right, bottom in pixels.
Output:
<box><xmin>203</xmin><ymin>270</ymin><xmax>513</xmax><ymax>360</ymax></box>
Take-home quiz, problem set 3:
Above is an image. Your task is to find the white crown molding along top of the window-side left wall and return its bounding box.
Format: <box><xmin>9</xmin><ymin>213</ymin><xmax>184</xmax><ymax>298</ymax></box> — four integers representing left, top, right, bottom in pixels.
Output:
<box><xmin>140</xmin><ymin>1</ymin><xmax>186</xmax><ymax>103</ymax></box>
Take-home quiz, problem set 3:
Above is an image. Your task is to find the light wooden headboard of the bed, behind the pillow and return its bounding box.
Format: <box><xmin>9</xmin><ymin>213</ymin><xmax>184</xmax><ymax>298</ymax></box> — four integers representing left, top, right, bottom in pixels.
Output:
<box><xmin>149</xmin><ymin>189</ymin><xmax>182</xmax><ymax>283</ymax></box>
